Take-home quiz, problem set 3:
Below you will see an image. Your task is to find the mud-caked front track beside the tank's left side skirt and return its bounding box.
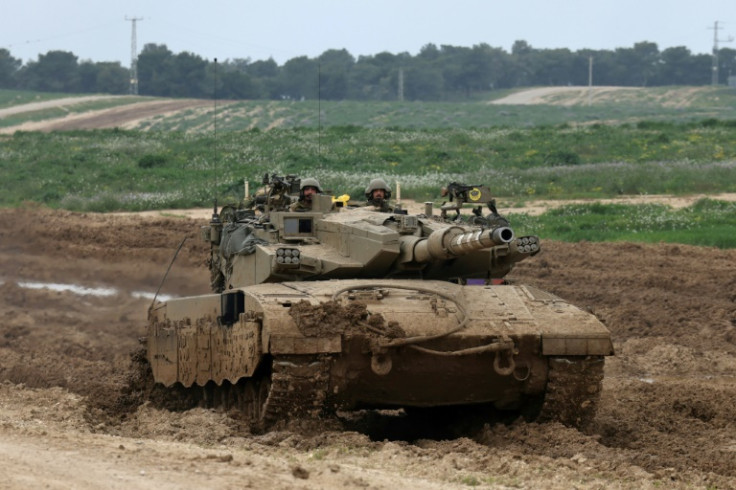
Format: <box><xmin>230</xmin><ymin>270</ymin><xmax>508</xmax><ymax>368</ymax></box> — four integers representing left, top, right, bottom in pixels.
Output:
<box><xmin>260</xmin><ymin>356</ymin><xmax>331</xmax><ymax>428</ymax></box>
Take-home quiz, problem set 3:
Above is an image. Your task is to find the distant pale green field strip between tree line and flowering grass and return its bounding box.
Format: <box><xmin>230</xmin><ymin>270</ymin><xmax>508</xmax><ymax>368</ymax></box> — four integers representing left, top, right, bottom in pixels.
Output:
<box><xmin>140</xmin><ymin>96</ymin><xmax>736</xmax><ymax>132</ymax></box>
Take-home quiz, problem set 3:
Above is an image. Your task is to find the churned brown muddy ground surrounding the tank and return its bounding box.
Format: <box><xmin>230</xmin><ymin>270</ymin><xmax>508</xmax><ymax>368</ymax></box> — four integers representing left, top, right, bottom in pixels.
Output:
<box><xmin>0</xmin><ymin>208</ymin><xmax>736</xmax><ymax>489</ymax></box>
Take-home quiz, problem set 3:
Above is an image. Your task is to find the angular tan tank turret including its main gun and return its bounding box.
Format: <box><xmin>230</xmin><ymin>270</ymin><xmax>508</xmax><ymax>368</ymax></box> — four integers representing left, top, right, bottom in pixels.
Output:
<box><xmin>202</xmin><ymin>176</ymin><xmax>540</xmax><ymax>292</ymax></box>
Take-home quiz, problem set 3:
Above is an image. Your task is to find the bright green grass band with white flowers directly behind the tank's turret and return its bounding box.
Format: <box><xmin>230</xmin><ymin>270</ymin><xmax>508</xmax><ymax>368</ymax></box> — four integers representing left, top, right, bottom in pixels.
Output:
<box><xmin>0</xmin><ymin>121</ymin><xmax>736</xmax><ymax>211</ymax></box>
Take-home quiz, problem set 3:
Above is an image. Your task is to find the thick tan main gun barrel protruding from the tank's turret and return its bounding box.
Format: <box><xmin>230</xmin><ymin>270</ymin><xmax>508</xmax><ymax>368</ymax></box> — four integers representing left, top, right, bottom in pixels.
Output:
<box><xmin>411</xmin><ymin>226</ymin><xmax>514</xmax><ymax>262</ymax></box>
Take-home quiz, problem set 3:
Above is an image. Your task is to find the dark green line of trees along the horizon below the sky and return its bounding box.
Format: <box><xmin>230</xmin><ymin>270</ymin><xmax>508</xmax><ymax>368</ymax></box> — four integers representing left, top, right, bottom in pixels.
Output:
<box><xmin>0</xmin><ymin>41</ymin><xmax>736</xmax><ymax>101</ymax></box>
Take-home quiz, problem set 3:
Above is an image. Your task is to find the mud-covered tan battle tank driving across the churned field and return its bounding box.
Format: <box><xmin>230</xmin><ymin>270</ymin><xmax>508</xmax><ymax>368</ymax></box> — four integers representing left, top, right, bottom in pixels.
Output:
<box><xmin>145</xmin><ymin>176</ymin><xmax>613</xmax><ymax>428</ymax></box>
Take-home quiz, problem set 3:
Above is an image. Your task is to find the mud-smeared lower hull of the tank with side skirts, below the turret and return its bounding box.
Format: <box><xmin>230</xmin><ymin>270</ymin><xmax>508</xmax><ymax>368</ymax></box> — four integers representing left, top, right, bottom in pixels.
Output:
<box><xmin>147</xmin><ymin>280</ymin><xmax>613</xmax><ymax>425</ymax></box>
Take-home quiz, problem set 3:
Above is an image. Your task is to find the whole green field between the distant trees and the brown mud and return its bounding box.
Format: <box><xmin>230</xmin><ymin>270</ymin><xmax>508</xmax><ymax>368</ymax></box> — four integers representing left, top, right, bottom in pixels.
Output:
<box><xmin>0</xmin><ymin>89</ymin><xmax>736</xmax><ymax>247</ymax></box>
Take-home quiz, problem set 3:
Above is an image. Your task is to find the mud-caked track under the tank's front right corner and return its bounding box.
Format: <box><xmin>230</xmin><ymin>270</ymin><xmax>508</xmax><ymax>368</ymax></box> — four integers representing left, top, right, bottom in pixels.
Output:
<box><xmin>537</xmin><ymin>356</ymin><xmax>605</xmax><ymax>429</ymax></box>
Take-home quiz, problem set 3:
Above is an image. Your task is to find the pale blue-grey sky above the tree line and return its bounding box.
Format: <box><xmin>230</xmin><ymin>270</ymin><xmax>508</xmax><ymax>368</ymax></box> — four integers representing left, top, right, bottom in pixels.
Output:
<box><xmin>0</xmin><ymin>0</ymin><xmax>736</xmax><ymax>67</ymax></box>
